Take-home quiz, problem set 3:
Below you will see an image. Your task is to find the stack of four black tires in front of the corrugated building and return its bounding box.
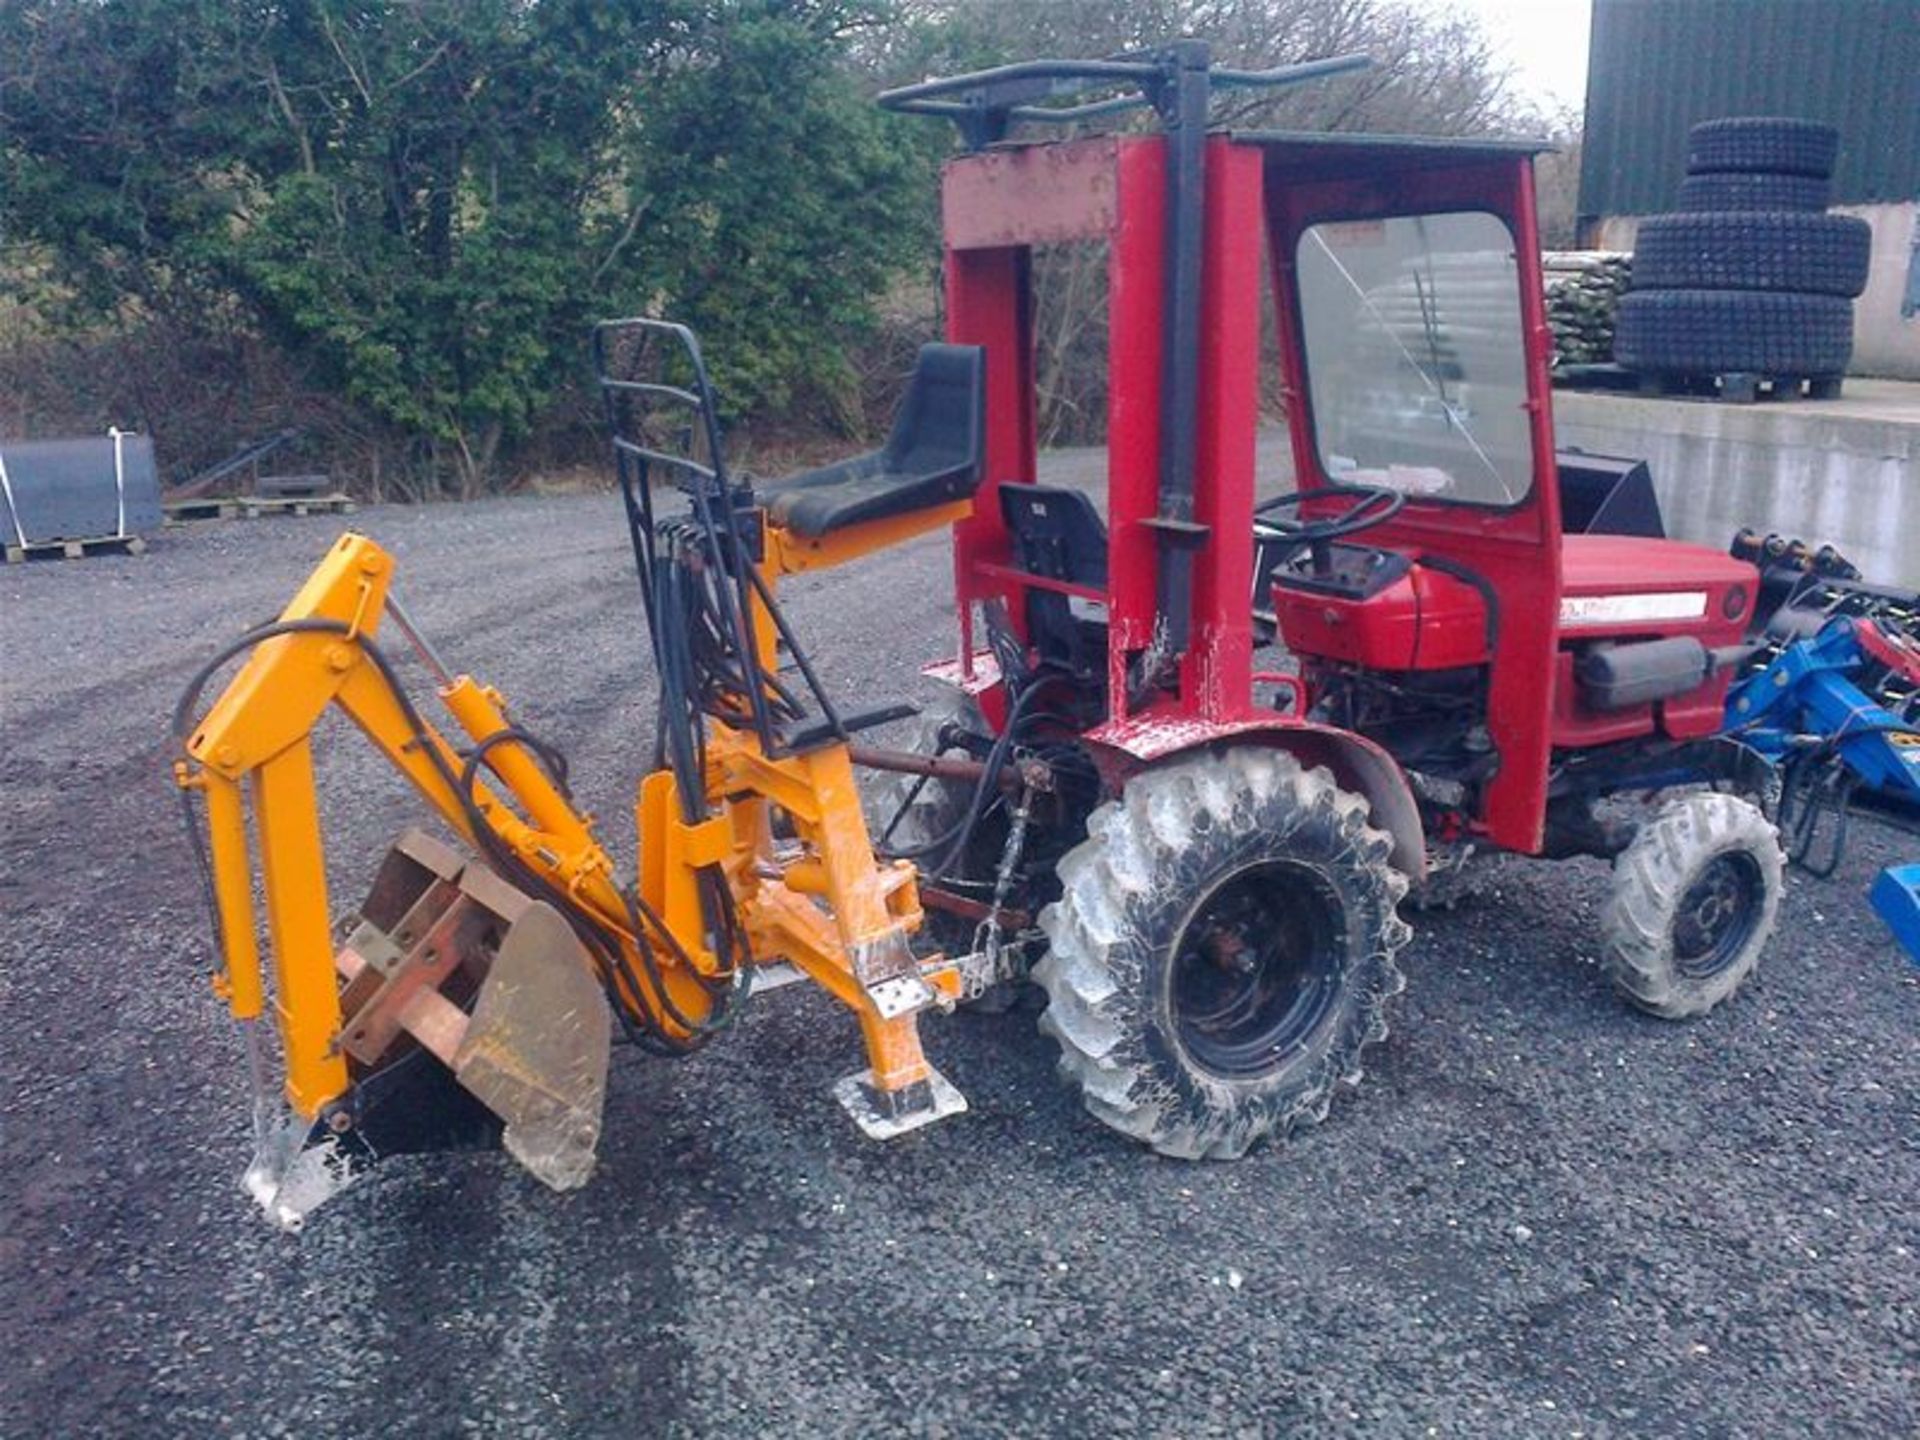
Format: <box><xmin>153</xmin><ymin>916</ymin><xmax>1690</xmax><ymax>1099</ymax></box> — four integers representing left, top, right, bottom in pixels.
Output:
<box><xmin>1613</xmin><ymin>117</ymin><xmax>1870</xmax><ymax>394</ymax></box>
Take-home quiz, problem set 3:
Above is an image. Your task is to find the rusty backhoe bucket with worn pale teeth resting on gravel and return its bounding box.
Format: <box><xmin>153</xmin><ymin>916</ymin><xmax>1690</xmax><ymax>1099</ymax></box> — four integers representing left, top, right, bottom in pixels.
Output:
<box><xmin>248</xmin><ymin>831</ymin><xmax>612</xmax><ymax>1229</ymax></box>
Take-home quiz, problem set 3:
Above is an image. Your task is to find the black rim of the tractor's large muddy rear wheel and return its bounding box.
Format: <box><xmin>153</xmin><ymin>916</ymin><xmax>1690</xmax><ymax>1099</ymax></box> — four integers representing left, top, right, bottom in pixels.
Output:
<box><xmin>1169</xmin><ymin>862</ymin><xmax>1346</xmax><ymax>1079</ymax></box>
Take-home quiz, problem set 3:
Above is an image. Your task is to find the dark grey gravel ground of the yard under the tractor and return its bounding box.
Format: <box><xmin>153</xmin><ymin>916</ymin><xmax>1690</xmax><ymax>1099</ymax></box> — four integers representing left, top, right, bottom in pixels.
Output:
<box><xmin>0</xmin><ymin>495</ymin><xmax>1920</xmax><ymax>1436</ymax></box>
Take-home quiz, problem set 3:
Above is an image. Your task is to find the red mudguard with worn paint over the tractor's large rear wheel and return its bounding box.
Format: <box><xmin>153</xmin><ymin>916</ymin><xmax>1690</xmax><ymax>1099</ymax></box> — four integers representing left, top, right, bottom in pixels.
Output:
<box><xmin>1085</xmin><ymin>712</ymin><xmax>1427</xmax><ymax>885</ymax></box>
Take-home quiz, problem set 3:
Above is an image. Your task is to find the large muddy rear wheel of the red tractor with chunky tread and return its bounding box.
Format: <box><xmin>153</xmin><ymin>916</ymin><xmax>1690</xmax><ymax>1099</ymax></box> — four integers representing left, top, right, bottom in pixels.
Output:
<box><xmin>1033</xmin><ymin>749</ymin><xmax>1413</xmax><ymax>1160</ymax></box>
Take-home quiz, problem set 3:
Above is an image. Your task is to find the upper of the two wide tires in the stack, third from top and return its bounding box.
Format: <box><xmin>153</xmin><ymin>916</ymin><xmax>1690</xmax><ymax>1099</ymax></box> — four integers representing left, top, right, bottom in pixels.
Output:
<box><xmin>1634</xmin><ymin>209</ymin><xmax>1874</xmax><ymax>300</ymax></box>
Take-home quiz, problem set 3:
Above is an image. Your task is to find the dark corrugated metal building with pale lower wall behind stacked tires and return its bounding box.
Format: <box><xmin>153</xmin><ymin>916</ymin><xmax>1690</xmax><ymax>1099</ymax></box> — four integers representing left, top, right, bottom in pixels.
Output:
<box><xmin>1580</xmin><ymin>0</ymin><xmax>1920</xmax><ymax>376</ymax></box>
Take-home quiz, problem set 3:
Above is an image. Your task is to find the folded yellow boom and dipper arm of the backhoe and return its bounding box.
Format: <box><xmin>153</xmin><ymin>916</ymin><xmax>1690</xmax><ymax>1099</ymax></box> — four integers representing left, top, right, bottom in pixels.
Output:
<box><xmin>177</xmin><ymin>534</ymin><xmax>652</xmax><ymax>1119</ymax></box>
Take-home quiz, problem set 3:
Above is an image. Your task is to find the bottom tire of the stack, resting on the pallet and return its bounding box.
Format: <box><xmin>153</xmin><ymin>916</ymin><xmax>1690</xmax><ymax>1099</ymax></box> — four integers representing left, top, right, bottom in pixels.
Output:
<box><xmin>1613</xmin><ymin>290</ymin><xmax>1853</xmax><ymax>376</ymax></box>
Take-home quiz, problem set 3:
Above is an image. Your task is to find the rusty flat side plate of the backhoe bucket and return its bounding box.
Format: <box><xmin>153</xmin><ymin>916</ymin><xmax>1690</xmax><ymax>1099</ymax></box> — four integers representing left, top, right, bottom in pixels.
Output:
<box><xmin>453</xmin><ymin>904</ymin><xmax>612</xmax><ymax>1190</ymax></box>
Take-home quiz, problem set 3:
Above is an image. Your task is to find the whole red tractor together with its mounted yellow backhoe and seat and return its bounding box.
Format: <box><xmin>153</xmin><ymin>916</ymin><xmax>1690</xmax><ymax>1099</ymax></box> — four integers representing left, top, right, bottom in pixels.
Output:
<box><xmin>175</xmin><ymin>42</ymin><xmax>1797</xmax><ymax>1225</ymax></box>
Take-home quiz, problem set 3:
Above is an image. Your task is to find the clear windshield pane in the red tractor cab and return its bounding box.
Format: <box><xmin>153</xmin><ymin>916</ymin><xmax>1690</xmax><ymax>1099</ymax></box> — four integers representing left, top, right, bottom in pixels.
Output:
<box><xmin>1296</xmin><ymin>211</ymin><xmax>1534</xmax><ymax>505</ymax></box>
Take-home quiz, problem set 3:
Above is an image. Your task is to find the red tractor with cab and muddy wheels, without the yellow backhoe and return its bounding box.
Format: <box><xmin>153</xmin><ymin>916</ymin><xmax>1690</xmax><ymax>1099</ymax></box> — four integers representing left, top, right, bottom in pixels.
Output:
<box><xmin>860</xmin><ymin>42</ymin><xmax>1782</xmax><ymax>1156</ymax></box>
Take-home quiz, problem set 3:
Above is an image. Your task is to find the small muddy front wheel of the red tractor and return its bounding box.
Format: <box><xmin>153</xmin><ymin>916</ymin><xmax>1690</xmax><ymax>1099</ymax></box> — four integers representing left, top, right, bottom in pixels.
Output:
<box><xmin>1601</xmin><ymin>791</ymin><xmax>1786</xmax><ymax>1020</ymax></box>
